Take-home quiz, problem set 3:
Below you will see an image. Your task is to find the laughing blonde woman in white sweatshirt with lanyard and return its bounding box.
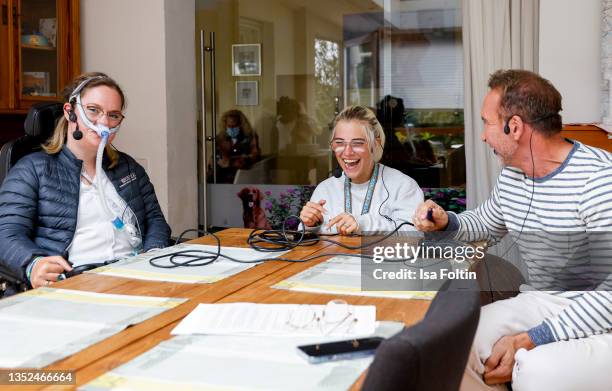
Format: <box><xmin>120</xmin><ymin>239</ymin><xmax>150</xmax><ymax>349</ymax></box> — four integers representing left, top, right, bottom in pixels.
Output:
<box><xmin>300</xmin><ymin>106</ymin><xmax>423</xmax><ymax>235</ymax></box>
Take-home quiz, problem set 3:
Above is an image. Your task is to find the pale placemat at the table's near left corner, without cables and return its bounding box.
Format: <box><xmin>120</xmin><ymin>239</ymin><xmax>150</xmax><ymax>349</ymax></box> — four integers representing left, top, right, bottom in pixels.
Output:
<box><xmin>0</xmin><ymin>288</ymin><xmax>185</xmax><ymax>368</ymax></box>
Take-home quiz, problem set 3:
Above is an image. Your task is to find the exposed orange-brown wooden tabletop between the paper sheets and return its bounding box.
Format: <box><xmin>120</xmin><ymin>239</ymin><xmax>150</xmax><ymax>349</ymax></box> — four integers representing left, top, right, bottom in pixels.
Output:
<box><xmin>8</xmin><ymin>229</ymin><xmax>430</xmax><ymax>390</ymax></box>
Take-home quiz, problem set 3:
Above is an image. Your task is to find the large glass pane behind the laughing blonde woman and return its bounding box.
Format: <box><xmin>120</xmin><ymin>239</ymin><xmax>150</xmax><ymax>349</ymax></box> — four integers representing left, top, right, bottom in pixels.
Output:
<box><xmin>195</xmin><ymin>0</ymin><xmax>465</xmax><ymax>228</ymax></box>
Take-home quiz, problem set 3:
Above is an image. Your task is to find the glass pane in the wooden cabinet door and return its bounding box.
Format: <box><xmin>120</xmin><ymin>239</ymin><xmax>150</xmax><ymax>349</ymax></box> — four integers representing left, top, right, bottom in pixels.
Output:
<box><xmin>20</xmin><ymin>0</ymin><xmax>59</xmax><ymax>97</ymax></box>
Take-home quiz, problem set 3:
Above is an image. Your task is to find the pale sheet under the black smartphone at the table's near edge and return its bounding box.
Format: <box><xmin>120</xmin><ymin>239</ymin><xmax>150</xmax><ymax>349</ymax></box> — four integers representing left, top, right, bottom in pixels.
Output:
<box><xmin>80</xmin><ymin>322</ymin><xmax>403</xmax><ymax>391</ymax></box>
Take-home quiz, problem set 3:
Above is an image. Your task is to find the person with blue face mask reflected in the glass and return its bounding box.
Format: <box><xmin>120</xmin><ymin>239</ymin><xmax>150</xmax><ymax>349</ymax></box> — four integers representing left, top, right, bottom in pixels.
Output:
<box><xmin>216</xmin><ymin>110</ymin><xmax>261</xmax><ymax>183</ymax></box>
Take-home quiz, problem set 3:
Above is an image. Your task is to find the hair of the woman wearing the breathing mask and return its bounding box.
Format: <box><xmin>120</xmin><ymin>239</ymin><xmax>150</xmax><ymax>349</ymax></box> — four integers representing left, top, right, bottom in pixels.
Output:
<box><xmin>42</xmin><ymin>72</ymin><xmax>125</xmax><ymax>168</ymax></box>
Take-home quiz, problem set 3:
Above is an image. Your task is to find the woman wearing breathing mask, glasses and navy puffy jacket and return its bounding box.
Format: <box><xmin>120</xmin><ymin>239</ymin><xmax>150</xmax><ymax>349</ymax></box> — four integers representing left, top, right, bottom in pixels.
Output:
<box><xmin>0</xmin><ymin>72</ymin><xmax>170</xmax><ymax>294</ymax></box>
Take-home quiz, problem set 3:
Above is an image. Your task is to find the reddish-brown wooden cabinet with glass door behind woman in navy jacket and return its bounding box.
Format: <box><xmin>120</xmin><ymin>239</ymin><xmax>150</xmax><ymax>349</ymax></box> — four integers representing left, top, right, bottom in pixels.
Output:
<box><xmin>0</xmin><ymin>0</ymin><xmax>80</xmax><ymax>116</ymax></box>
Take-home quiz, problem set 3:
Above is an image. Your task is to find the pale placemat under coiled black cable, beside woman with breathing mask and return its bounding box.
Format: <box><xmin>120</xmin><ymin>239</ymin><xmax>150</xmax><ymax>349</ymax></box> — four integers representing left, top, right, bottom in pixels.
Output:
<box><xmin>89</xmin><ymin>243</ymin><xmax>286</xmax><ymax>284</ymax></box>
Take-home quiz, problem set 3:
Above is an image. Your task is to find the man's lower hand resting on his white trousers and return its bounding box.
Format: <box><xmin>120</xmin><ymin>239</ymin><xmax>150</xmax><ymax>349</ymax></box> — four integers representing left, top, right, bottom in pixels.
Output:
<box><xmin>484</xmin><ymin>333</ymin><xmax>535</xmax><ymax>385</ymax></box>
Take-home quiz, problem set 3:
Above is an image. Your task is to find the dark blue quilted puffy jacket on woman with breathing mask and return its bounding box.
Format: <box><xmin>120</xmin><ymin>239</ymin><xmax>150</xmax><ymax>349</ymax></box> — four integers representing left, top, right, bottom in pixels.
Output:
<box><xmin>0</xmin><ymin>146</ymin><xmax>170</xmax><ymax>281</ymax></box>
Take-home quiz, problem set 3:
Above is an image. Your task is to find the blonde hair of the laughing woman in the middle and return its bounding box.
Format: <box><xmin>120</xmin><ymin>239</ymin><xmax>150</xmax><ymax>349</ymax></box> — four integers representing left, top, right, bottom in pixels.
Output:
<box><xmin>332</xmin><ymin>105</ymin><xmax>385</xmax><ymax>163</ymax></box>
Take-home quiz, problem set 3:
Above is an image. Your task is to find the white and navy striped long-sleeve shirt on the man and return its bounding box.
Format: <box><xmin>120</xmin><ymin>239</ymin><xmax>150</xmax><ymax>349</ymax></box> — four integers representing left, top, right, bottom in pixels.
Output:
<box><xmin>448</xmin><ymin>141</ymin><xmax>612</xmax><ymax>345</ymax></box>
